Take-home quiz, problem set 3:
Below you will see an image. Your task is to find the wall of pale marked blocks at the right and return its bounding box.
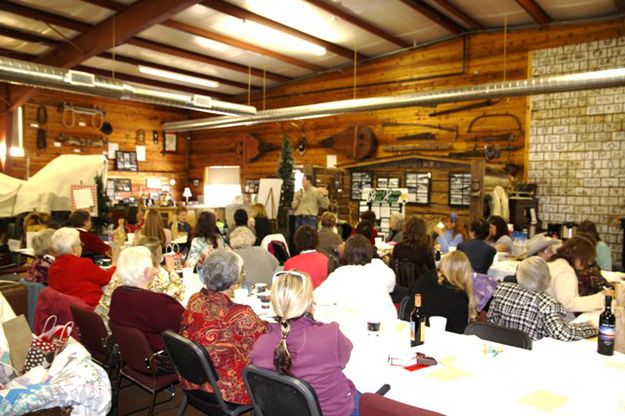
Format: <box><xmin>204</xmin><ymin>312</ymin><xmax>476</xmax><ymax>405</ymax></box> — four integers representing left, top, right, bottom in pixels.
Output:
<box><xmin>528</xmin><ymin>38</ymin><xmax>625</xmax><ymax>264</ymax></box>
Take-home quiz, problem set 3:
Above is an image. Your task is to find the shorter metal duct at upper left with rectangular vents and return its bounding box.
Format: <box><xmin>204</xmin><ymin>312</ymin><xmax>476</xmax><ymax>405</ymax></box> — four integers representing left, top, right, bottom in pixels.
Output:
<box><xmin>0</xmin><ymin>57</ymin><xmax>256</xmax><ymax>115</ymax></box>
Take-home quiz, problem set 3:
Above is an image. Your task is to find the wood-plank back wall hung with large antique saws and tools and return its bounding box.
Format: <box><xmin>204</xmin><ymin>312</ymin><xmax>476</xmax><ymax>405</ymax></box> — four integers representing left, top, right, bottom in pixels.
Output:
<box><xmin>189</xmin><ymin>20</ymin><xmax>625</xmax><ymax>215</ymax></box>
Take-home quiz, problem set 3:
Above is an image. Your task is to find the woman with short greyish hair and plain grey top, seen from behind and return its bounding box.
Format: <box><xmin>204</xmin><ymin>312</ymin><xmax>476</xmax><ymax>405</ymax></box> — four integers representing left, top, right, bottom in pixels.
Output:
<box><xmin>230</xmin><ymin>227</ymin><xmax>280</xmax><ymax>285</ymax></box>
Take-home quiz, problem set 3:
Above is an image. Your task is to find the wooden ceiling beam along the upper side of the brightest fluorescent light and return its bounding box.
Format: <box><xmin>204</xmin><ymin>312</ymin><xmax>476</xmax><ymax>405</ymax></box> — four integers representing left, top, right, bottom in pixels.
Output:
<box><xmin>202</xmin><ymin>0</ymin><xmax>367</xmax><ymax>60</ymax></box>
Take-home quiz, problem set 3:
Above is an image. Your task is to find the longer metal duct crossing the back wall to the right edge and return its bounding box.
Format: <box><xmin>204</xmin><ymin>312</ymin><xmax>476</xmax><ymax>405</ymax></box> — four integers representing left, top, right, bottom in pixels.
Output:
<box><xmin>163</xmin><ymin>68</ymin><xmax>625</xmax><ymax>131</ymax></box>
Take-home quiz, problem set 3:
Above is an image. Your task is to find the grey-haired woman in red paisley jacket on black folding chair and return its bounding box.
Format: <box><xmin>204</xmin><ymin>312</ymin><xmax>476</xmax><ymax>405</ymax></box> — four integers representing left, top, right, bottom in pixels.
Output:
<box><xmin>180</xmin><ymin>249</ymin><xmax>267</xmax><ymax>404</ymax></box>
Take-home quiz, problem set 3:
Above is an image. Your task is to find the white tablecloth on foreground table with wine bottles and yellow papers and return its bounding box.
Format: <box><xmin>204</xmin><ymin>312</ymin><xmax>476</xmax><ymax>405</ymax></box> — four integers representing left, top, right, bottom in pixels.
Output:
<box><xmin>345</xmin><ymin>328</ymin><xmax>625</xmax><ymax>416</ymax></box>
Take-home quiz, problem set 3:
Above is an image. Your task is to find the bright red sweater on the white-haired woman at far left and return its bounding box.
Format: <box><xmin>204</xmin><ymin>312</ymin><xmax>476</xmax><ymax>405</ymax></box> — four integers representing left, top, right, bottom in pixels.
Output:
<box><xmin>48</xmin><ymin>254</ymin><xmax>115</xmax><ymax>307</ymax></box>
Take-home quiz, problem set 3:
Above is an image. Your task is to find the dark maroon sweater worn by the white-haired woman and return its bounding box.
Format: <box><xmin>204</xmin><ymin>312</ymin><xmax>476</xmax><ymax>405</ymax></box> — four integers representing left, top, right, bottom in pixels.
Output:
<box><xmin>109</xmin><ymin>286</ymin><xmax>184</xmax><ymax>351</ymax></box>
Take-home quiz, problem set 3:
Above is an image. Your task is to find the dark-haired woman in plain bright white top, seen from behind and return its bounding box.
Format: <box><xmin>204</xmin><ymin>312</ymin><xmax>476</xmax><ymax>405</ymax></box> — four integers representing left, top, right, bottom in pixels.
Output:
<box><xmin>315</xmin><ymin>234</ymin><xmax>397</xmax><ymax>322</ymax></box>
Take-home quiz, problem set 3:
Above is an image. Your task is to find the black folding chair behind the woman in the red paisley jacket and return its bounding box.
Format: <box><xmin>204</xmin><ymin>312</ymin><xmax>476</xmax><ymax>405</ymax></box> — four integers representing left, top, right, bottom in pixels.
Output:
<box><xmin>163</xmin><ymin>330</ymin><xmax>252</xmax><ymax>416</ymax></box>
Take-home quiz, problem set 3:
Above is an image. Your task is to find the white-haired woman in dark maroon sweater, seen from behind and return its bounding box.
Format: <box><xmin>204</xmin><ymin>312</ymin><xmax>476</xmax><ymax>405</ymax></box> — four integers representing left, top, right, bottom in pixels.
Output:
<box><xmin>109</xmin><ymin>247</ymin><xmax>184</xmax><ymax>352</ymax></box>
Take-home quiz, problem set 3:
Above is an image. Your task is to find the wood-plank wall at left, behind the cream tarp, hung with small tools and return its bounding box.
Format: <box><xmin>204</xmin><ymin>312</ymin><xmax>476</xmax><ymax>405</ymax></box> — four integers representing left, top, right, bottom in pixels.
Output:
<box><xmin>7</xmin><ymin>90</ymin><xmax>188</xmax><ymax>200</ymax></box>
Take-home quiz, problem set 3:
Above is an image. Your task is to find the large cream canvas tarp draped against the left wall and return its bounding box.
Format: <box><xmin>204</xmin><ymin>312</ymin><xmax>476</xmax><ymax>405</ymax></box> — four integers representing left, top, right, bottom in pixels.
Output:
<box><xmin>8</xmin><ymin>155</ymin><xmax>107</xmax><ymax>216</ymax></box>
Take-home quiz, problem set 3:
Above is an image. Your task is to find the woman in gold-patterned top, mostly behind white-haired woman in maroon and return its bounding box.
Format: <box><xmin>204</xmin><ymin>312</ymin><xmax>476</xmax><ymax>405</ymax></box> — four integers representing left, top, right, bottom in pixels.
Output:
<box><xmin>95</xmin><ymin>236</ymin><xmax>185</xmax><ymax>328</ymax></box>
